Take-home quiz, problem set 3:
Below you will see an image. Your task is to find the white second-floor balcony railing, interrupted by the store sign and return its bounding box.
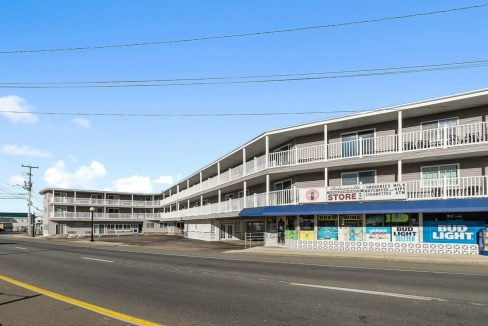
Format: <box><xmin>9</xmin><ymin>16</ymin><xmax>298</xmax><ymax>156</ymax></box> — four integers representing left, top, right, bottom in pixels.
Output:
<box><xmin>159</xmin><ymin>176</ymin><xmax>488</xmax><ymax>221</ymax></box>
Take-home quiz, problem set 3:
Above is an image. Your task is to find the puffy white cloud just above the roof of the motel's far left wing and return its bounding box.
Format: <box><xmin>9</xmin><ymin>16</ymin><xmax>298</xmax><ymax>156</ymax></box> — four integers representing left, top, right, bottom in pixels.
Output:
<box><xmin>44</xmin><ymin>161</ymin><xmax>107</xmax><ymax>188</ymax></box>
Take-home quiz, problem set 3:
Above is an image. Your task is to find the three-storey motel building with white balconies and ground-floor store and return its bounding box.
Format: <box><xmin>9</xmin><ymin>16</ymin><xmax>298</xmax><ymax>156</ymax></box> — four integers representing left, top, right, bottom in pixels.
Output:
<box><xmin>41</xmin><ymin>89</ymin><xmax>488</xmax><ymax>254</ymax></box>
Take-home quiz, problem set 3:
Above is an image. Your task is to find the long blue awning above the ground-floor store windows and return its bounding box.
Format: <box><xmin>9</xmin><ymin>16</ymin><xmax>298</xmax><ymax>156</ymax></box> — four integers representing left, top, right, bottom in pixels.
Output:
<box><xmin>239</xmin><ymin>198</ymin><xmax>488</xmax><ymax>217</ymax></box>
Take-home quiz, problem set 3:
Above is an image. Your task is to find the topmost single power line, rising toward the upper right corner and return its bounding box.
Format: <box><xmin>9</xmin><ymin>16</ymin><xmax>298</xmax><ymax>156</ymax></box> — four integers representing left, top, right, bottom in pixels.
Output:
<box><xmin>0</xmin><ymin>3</ymin><xmax>488</xmax><ymax>54</ymax></box>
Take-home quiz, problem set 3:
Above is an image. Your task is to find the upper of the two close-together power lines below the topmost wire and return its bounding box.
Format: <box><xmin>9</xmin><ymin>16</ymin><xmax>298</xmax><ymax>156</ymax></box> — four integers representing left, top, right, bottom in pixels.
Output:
<box><xmin>0</xmin><ymin>59</ymin><xmax>488</xmax><ymax>85</ymax></box>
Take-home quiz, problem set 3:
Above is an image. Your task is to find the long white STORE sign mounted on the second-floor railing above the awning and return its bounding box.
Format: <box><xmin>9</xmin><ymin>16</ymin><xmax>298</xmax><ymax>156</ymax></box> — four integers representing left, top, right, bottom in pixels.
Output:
<box><xmin>299</xmin><ymin>183</ymin><xmax>407</xmax><ymax>203</ymax></box>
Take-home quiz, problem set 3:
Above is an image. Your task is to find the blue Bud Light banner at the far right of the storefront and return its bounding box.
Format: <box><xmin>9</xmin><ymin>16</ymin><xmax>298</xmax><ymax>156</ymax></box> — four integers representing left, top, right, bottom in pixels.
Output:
<box><xmin>424</xmin><ymin>221</ymin><xmax>485</xmax><ymax>244</ymax></box>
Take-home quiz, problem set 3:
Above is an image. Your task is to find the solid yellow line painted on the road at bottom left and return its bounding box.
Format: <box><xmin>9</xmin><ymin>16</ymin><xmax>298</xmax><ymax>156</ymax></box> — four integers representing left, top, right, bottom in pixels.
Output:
<box><xmin>0</xmin><ymin>274</ymin><xmax>162</xmax><ymax>326</ymax></box>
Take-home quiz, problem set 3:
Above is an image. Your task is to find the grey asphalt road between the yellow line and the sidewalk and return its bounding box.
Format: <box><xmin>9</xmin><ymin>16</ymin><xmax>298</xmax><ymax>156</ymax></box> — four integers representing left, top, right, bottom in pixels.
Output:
<box><xmin>0</xmin><ymin>237</ymin><xmax>488</xmax><ymax>326</ymax></box>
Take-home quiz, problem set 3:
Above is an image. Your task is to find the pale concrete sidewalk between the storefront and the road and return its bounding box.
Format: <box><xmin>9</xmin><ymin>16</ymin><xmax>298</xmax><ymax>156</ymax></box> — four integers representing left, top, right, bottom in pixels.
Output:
<box><xmin>231</xmin><ymin>247</ymin><xmax>488</xmax><ymax>266</ymax></box>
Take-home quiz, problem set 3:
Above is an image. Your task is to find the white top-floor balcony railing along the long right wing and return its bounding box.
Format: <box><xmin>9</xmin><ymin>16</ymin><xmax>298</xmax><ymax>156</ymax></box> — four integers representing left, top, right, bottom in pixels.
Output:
<box><xmin>107</xmin><ymin>122</ymin><xmax>488</xmax><ymax>206</ymax></box>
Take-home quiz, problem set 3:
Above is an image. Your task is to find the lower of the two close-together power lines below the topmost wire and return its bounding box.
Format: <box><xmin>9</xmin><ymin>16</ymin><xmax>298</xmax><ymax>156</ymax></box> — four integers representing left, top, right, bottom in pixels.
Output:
<box><xmin>0</xmin><ymin>60</ymin><xmax>488</xmax><ymax>88</ymax></box>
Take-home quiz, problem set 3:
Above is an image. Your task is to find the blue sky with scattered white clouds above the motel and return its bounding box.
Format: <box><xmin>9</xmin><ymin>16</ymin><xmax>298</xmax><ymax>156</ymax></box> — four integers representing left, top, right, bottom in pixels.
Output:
<box><xmin>0</xmin><ymin>0</ymin><xmax>488</xmax><ymax>211</ymax></box>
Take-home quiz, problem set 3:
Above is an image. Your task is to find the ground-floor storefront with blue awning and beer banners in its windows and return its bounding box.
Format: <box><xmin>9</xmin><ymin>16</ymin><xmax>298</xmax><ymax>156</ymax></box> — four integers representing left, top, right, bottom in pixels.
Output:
<box><xmin>241</xmin><ymin>199</ymin><xmax>488</xmax><ymax>254</ymax></box>
